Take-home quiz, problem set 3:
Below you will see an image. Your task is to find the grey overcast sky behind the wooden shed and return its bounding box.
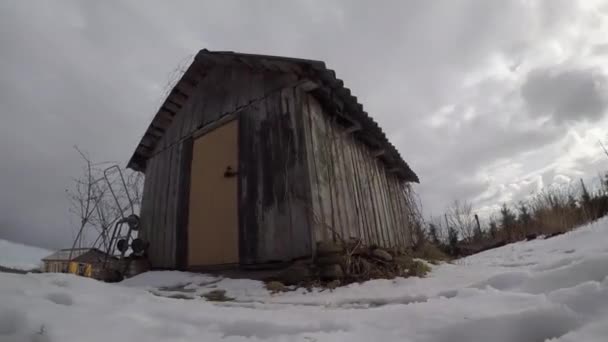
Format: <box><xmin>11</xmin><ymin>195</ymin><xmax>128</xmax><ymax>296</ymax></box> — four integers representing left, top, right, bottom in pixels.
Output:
<box><xmin>0</xmin><ymin>0</ymin><xmax>608</xmax><ymax>248</ymax></box>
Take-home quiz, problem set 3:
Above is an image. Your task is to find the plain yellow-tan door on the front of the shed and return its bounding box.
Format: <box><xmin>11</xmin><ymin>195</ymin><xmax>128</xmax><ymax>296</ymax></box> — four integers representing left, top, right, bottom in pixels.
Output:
<box><xmin>188</xmin><ymin>120</ymin><xmax>239</xmax><ymax>267</ymax></box>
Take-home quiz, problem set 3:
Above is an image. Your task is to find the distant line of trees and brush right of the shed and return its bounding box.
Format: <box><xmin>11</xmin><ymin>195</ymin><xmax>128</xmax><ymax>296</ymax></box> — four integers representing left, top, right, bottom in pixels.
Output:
<box><xmin>424</xmin><ymin>173</ymin><xmax>608</xmax><ymax>257</ymax></box>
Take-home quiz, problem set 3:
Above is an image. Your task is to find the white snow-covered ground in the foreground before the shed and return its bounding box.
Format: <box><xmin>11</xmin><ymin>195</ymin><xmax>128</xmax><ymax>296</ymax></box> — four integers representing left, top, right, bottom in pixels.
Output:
<box><xmin>0</xmin><ymin>219</ymin><xmax>608</xmax><ymax>342</ymax></box>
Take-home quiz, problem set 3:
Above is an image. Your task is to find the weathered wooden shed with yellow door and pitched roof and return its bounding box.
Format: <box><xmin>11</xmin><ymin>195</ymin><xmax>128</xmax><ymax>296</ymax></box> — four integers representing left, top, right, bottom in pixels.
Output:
<box><xmin>128</xmin><ymin>50</ymin><xmax>418</xmax><ymax>269</ymax></box>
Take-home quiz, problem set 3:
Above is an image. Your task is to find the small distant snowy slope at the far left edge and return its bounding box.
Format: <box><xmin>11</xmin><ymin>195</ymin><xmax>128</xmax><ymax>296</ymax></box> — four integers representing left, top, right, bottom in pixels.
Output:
<box><xmin>0</xmin><ymin>239</ymin><xmax>52</xmax><ymax>271</ymax></box>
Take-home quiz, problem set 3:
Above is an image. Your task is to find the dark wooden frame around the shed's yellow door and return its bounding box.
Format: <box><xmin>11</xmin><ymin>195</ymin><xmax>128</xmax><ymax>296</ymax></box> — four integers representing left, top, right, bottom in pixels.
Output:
<box><xmin>175</xmin><ymin>112</ymin><xmax>244</xmax><ymax>271</ymax></box>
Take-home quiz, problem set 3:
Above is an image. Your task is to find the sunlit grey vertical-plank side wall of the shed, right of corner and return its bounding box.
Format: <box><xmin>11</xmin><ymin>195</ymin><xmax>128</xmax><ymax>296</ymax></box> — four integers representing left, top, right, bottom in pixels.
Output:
<box><xmin>303</xmin><ymin>95</ymin><xmax>411</xmax><ymax>247</ymax></box>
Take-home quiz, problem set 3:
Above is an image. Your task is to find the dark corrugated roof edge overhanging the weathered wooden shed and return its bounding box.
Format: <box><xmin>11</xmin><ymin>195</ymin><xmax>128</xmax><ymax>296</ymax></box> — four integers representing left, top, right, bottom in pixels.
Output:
<box><xmin>127</xmin><ymin>49</ymin><xmax>419</xmax><ymax>183</ymax></box>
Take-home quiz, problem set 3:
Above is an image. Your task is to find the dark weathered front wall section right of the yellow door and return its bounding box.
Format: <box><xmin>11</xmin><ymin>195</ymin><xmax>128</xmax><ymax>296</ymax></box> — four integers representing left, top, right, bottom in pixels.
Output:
<box><xmin>239</xmin><ymin>87</ymin><xmax>311</xmax><ymax>264</ymax></box>
